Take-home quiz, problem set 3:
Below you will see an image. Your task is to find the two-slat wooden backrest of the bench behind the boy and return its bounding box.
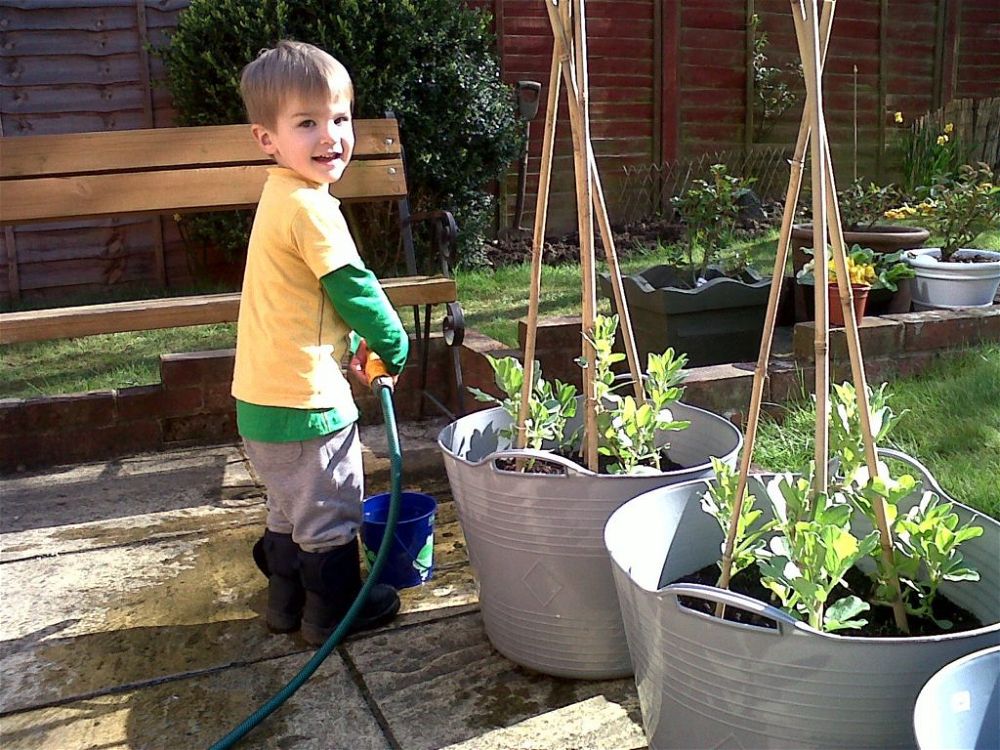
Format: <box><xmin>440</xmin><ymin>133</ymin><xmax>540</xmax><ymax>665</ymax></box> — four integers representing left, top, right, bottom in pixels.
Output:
<box><xmin>0</xmin><ymin>118</ymin><xmax>406</xmax><ymax>225</ymax></box>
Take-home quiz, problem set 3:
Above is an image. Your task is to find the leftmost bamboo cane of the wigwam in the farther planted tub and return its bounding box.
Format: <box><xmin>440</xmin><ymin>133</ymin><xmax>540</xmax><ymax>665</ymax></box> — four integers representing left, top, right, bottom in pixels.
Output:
<box><xmin>516</xmin><ymin>42</ymin><xmax>563</xmax><ymax>448</ymax></box>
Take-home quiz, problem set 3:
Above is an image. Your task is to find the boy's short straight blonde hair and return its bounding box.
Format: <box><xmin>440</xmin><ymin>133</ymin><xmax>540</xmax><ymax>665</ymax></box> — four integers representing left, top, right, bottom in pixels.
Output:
<box><xmin>240</xmin><ymin>39</ymin><xmax>354</xmax><ymax>128</ymax></box>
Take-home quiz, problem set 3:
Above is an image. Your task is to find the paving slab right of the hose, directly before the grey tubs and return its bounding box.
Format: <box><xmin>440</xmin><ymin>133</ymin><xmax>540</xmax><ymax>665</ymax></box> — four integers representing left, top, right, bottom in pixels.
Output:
<box><xmin>345</xmin><ymin>612</ymin><xmax>645</xmax><ymax>750</ymax></box>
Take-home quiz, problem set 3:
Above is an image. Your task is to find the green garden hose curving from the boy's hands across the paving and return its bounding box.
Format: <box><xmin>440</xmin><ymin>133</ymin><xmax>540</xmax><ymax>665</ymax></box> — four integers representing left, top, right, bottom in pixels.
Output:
<box><xmin>210</xmin><ymin>382</ymin><xmax>403</xmax><ymax>750</ymax></box>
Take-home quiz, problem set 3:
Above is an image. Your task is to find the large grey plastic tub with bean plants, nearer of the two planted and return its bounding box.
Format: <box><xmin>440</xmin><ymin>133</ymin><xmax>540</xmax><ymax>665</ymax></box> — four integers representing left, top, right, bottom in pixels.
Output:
<box><xmin>605</xmin><ymin>468</ymin><xmax>1000</xmax><ymax>750</ymax></box>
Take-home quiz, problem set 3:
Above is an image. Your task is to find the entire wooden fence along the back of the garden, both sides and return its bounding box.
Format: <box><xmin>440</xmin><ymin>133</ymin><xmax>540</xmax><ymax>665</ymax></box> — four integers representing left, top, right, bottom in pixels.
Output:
<box><xmin>0</xmin><ymin>0</ymin><xmax>1000</xmax><ymax>303</ymax></box>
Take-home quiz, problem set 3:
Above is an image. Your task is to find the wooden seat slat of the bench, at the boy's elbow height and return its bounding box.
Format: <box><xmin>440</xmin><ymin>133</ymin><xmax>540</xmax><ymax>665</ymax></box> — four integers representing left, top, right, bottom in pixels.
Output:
<box><xmin>0</xmin><ymin>276</ymin><xmax>457</xmax><ymax>344</ymax></box>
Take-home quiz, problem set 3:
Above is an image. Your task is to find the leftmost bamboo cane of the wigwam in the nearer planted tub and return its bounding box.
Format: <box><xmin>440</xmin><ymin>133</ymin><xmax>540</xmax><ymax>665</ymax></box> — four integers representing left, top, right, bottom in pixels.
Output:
<box><xmin>716</xmin><ymin>2</ymin><xmax>835</xmax><ymax>604</ymax></box>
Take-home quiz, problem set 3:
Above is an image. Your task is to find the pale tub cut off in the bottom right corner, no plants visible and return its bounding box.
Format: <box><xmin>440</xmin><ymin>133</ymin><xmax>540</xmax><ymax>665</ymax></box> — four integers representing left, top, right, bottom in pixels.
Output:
<box><xmin>913</xmin><ymin>646</ymin><xmax>1000</xmax><ymax>750</ymax></box>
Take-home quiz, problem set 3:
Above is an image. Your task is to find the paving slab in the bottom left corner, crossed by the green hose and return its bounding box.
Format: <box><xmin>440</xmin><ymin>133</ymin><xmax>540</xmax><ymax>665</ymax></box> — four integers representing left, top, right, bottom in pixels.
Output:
<box><xmin>0</xmin><ymin>653</ymin><xmax>391</xmax><ymax>750</ymax></box>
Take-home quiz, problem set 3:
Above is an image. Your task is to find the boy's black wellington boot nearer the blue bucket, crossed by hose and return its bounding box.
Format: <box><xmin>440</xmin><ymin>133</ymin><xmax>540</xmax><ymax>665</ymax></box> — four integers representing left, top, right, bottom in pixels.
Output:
<box><xmin>299</xmin><ymin>537</ymin><xmax>399</xmax><ymax>646</ymax></box>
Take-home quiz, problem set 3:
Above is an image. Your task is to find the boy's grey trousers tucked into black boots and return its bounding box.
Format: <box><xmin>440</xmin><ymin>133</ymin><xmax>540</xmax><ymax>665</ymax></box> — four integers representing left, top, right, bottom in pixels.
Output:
<box><xmin>243</xmin><ymin>424</ymin><xmax>364</xmax><ymax>552</ymax></box>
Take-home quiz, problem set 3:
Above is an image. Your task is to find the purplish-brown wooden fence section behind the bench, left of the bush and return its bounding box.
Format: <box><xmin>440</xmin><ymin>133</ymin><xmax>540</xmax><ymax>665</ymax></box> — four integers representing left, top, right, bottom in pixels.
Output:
<box><xmin>0</xmin><ymin>0</ymin><xmax>190</xmax><ymax>302</ymax></box>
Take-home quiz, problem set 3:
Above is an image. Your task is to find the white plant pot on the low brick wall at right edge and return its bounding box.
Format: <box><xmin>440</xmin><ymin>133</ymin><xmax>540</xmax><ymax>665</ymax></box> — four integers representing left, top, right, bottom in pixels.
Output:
<box><xmin>903</xmin><ymin>247</ymin><xmax>1000</xmax><ymax>310</ymax></box>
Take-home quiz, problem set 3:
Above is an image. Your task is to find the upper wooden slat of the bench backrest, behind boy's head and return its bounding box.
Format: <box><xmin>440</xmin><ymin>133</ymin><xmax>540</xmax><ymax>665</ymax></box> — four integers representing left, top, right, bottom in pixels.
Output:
<box><xmin>0</xmin><ymin>119</ymin><xmax>400</xmax><ymax>179</ymax></box>
